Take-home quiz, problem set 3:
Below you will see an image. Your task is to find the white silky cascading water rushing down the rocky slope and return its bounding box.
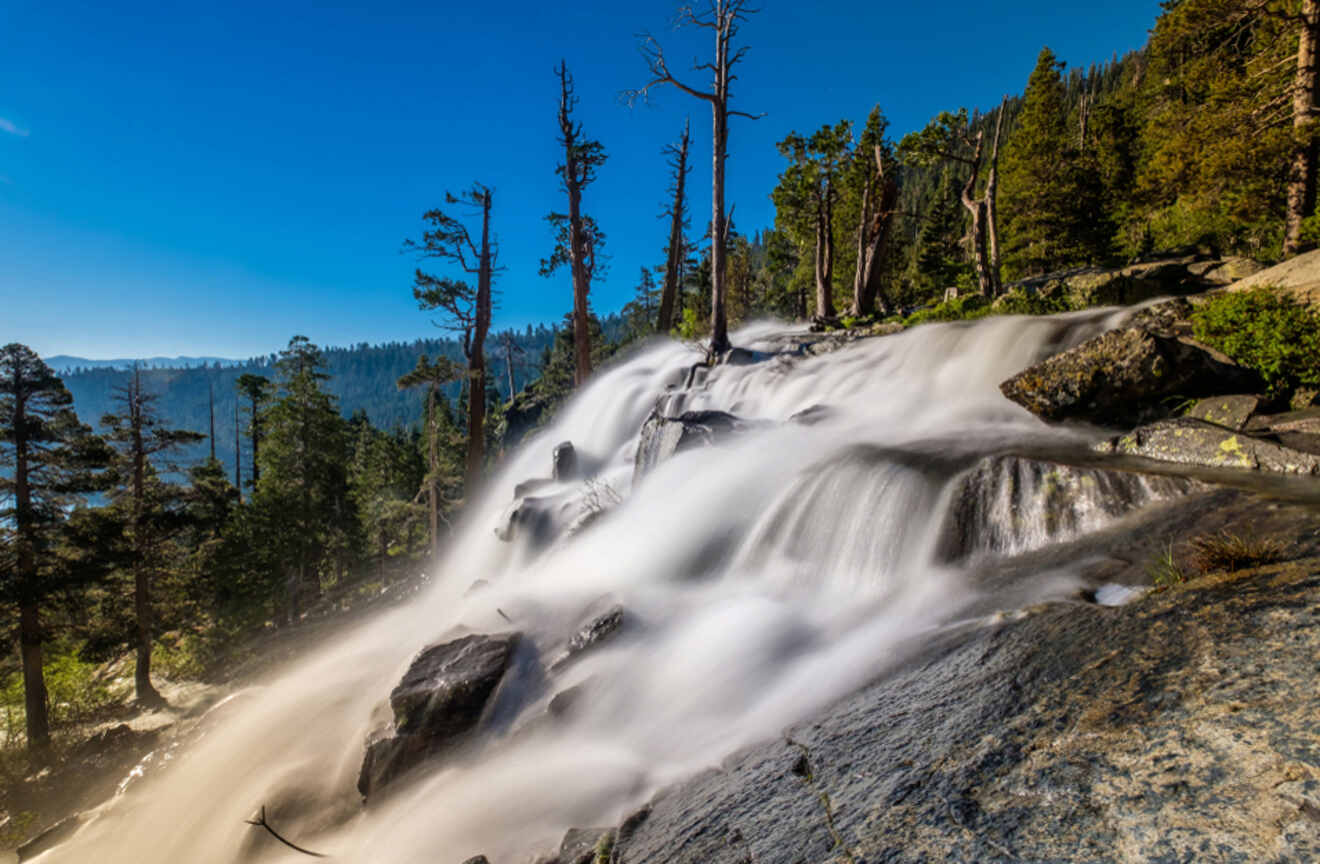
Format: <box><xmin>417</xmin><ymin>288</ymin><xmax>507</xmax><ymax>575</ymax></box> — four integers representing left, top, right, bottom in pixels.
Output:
<box><xmin>42</xmin><ymin>313</ymin><xmax>1198</xmax><ymax>864</ymax></box>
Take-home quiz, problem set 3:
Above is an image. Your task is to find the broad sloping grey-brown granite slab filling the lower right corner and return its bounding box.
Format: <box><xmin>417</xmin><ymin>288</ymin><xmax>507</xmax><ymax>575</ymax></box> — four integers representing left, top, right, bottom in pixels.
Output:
<box><xmin>604</xmin><ymin>540</ymin><xmax>1320</xmax><ymax>864</ymax></box>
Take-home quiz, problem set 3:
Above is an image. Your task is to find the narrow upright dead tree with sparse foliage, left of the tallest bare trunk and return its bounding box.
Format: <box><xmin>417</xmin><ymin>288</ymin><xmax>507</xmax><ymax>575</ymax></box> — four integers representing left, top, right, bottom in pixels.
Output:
<box><xmin>541</xmin><ymin>61</ymin><xmax>606</xmax><ymax>386</ymax></box>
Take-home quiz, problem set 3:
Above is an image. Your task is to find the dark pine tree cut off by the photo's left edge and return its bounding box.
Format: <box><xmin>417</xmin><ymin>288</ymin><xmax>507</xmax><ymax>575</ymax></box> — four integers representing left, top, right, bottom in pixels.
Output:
<box><xmin>0</xmin><ymin>343</ymin><xmax>110</xmax><ymax>762</ymax></box>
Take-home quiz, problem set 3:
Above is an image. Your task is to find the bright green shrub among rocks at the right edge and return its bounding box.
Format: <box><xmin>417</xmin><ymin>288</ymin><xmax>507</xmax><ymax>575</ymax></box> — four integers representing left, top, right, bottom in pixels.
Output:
<box><xmin>1192</xmin><ymin>288</ymin><xmax>1320</xmax><ymax>393</ymax></box>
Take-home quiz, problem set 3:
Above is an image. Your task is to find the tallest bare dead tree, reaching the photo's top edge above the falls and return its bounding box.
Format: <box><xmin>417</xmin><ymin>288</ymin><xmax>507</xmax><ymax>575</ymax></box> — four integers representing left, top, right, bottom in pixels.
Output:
<box><xmin>624</xmin><ymin>0</ymin><xmax>764</xmax><ymax>354</ymax></box>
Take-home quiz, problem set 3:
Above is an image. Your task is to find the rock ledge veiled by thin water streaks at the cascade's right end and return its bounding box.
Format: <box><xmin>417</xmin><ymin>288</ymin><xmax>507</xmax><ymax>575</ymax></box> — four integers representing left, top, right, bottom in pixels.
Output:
<box><xmin>940</xmin><ymin>455</ymin><xmax>1205</xmax><ymax>561</ymax></box>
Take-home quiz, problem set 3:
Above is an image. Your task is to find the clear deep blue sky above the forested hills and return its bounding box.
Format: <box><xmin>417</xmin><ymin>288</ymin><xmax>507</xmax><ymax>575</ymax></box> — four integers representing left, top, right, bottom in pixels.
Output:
<box><xmin>0</xmin><ymin>0</ymin><xmax>1159</xmax><ymax>357</ymax></box>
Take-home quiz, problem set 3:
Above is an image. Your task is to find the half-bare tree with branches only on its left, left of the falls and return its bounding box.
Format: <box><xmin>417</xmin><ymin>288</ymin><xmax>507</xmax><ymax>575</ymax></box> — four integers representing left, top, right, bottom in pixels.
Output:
<box><xmin>404</xmin><ymin>183</ymin><xmax>499</xmax><ymax>496</ymax></box>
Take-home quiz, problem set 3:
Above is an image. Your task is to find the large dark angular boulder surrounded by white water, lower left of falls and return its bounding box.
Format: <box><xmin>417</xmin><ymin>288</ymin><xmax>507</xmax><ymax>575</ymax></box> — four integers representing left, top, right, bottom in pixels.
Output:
<box><xmin>358</xmin><ymin>633</ymin><xmax>521</xmax><ymax>797</ymax></box>
